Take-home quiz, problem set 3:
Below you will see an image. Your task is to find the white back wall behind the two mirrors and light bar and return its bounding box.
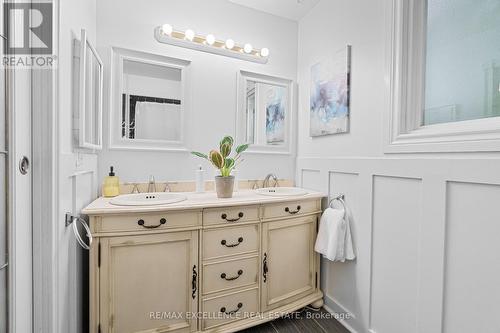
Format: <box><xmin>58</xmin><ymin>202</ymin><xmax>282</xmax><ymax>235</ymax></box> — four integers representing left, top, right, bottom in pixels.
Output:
<box><xmin>97</xmin><ymin>0</ymin><xmax>297</xmax><ymax>182</ymax></box>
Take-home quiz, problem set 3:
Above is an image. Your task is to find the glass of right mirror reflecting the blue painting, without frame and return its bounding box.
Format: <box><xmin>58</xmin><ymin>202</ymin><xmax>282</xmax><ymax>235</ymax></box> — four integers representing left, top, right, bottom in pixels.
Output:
<box><xmin>245</xmin><ymin>80</ymin><xmax>288</xmax><ymax>145</ymax></box>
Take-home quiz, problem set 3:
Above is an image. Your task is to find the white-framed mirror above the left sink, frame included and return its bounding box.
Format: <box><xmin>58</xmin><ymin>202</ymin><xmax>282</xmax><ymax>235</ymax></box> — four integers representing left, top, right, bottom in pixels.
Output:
<box><xmin>110</xmin><ymin>48</ymin><xmax>190</xmax><ymax>150</ymax></box>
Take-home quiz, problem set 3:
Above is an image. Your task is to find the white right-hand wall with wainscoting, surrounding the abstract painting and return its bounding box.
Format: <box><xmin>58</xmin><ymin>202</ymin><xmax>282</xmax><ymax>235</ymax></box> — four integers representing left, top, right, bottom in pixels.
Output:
<box><xmin>297</xmin><ymin>0</ymin><xmax>500</xmax><ymax>333</ymax></box>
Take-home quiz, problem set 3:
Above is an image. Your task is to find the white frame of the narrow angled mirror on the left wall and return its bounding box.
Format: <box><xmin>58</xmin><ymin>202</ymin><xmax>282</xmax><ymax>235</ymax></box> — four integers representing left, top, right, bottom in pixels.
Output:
<box><xmin>75</xmin><ymin>29</ymin><xmax>104</xmax><ymax>150</ymax></box>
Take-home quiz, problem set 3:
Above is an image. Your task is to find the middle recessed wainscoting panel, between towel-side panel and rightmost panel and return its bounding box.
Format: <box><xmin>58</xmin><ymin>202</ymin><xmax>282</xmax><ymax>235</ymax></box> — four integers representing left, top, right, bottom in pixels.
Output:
<box><xmin>370</xmin><ymin>176</ymin><xmax>422</xmax><ymax>333</ymax></box>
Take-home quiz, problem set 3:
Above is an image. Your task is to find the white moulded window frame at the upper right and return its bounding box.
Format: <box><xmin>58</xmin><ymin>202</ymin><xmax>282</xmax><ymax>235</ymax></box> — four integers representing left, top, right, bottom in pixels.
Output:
<box><xmin>384</xmin><ymin>0</ymin><xmax>500</xmax><ymax>153</ymax></box>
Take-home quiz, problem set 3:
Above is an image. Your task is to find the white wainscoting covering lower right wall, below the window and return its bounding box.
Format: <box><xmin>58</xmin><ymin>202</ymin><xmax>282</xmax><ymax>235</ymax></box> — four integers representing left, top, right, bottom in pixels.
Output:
<box><xmin>297</xmin><ymin>157</ymin><xmax>500</xmax><ymax>333</ymax></box>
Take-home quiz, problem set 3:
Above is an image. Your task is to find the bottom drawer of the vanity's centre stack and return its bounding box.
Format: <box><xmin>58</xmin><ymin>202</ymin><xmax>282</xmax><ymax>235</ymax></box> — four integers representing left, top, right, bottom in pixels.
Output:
<box><xmin>201</xmin><ymin>288</ymin><xmax>259</xmax><ymax>330</ymax></box>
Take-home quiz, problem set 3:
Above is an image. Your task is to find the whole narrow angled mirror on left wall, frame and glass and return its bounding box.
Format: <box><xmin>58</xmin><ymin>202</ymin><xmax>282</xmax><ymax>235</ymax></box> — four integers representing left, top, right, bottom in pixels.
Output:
<box><xmin>75</xmin><ymin>29</ymin><xmax>103</xmax><ymax>150</ymax></box>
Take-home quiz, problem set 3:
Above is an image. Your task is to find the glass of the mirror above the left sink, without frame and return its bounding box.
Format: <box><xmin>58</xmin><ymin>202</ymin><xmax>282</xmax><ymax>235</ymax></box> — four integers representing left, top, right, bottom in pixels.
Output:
<box><xmin>121</xmin><ymin>59</ymin><xmax>182</xmax><ymax>141</ymax></box>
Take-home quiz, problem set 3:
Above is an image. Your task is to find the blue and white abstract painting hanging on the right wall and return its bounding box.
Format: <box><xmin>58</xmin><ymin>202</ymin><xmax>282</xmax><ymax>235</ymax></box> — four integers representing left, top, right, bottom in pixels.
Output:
<box><xmin>309</xmin><ymin>45</ymin><xmax>351</xmax><ymax>137</ymax></box>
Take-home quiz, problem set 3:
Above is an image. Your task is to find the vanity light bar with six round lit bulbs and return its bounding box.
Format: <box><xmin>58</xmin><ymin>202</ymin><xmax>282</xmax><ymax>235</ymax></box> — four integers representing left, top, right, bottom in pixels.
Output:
<box><xmin>154</xmin><ymin>23</ymin><xmax>269</xmax><ymax>64</ymax></box>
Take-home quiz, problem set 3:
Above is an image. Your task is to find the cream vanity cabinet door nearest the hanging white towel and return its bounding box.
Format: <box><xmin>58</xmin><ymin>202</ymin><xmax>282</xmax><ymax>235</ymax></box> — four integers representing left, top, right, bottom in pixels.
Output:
<box><xmin>261</xmin><ymin>216</ymin><xmax>316</xmax><ymax>311</ymax></box>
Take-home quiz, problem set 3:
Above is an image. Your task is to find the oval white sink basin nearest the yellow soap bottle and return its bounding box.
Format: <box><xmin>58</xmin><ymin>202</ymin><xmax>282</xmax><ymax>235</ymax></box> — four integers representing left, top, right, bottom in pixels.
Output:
<box><xmin>109</xmin><ymin>192</ymin><xmax>187</xmax><ymax>206</ymax></box>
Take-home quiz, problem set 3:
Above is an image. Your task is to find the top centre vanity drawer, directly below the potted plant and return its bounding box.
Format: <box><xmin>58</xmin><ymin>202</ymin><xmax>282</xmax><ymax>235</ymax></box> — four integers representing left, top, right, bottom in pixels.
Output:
<box><xmin>203</xmin><ymin>206</ymin><xmax>259</xmax><ymax>225</ymax></box>
